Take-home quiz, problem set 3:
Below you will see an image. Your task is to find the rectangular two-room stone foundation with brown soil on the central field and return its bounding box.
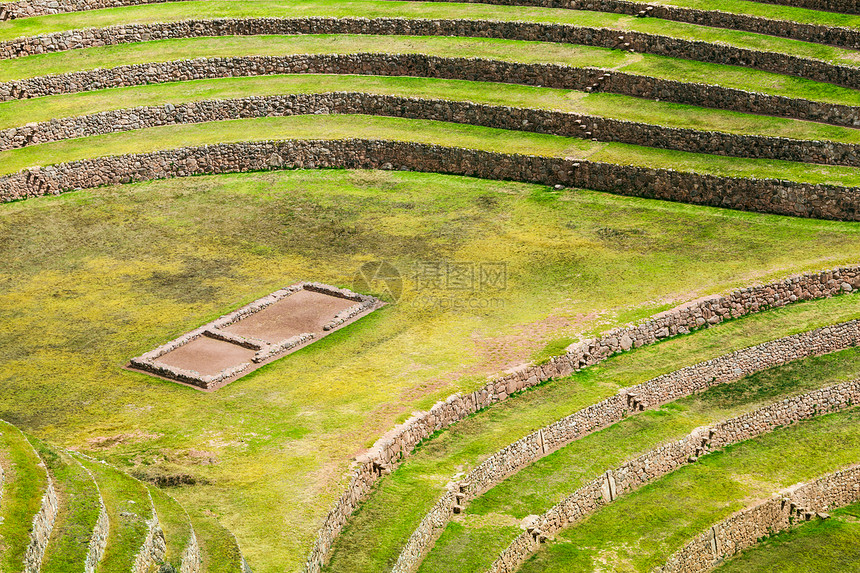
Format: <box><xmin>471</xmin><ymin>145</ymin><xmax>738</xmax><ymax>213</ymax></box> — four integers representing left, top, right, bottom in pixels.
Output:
<box><xmin>128</xmin><ymin>283</ymin><xmax>383</xmax><ymax>390</ymax></box>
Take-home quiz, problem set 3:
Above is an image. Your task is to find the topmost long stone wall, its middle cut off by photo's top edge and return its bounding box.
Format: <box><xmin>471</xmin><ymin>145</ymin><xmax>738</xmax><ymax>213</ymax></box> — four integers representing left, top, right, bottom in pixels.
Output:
<box><xmin>0</xmin><ymin>0</ymin><xmax>860</xmax><ymax>49</ymax></box>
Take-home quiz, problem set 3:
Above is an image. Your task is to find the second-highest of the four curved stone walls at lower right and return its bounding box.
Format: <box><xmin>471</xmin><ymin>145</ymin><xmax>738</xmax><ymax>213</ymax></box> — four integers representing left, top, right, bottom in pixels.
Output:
<box><xmin>392</xmin><ymin>320</ymin><xmax>860</xmax><ymax>573</ymax></box>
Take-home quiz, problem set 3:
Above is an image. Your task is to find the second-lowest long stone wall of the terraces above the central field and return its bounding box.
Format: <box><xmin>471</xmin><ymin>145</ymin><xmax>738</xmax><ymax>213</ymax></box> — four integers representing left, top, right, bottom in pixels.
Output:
<box><xmin>6</xmin><ymin>92</ymin><xmax>860</xmax><ymax>166</ymax></box>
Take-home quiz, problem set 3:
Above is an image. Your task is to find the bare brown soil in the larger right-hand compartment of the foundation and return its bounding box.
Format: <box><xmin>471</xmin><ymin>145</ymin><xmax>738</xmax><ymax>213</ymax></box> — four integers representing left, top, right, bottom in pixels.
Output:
<box><xmin>223</xmin><ymin>290</ymin><xmax>356</xmax><ymax>344</ymax></box>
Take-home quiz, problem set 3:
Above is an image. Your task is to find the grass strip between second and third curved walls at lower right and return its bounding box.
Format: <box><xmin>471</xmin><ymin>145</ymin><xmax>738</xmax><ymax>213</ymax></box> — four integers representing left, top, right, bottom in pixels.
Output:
<box><xmin>421</xmin><ymin>349</ymin><xmax>860</xmax><ymax>573</ymax></box>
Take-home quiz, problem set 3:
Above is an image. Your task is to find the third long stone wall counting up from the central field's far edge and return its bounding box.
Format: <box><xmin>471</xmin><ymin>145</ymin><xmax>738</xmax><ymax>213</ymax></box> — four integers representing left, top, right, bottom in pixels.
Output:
<box><xmin>0</xmin><ymin>53</ymin><xmax>860</xmax><ymax>127</ymax></box>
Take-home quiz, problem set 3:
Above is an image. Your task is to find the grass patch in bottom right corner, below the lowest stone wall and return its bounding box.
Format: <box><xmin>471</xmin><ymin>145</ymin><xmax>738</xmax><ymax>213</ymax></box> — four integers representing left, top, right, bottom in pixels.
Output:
<box><xmin>716</xmin><ymin>503</ymin><xmax>860</xmax><ymax>573</ymax></box>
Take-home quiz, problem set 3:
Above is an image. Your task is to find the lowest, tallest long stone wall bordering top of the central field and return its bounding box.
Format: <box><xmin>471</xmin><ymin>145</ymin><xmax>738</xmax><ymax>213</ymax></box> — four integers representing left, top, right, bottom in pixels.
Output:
<box><xmin>6</xmin><ymin>139</ymin><xmax>860</xmax><ymax>220</ymax></box>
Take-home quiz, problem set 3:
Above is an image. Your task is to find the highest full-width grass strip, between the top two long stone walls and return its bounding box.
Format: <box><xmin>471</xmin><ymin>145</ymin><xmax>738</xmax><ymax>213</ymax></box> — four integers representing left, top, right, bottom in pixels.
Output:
<box><xmin>0</xmin><ymin>0</ymin><xmax>860</xmax><ymax>66</ymax></box>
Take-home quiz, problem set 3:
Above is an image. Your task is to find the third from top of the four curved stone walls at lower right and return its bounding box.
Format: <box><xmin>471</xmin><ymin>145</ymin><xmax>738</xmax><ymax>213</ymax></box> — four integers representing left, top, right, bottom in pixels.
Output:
<box><xmin>488</xmin><ymin>380</ymin><xmax>860</xmax><ymax>573</ymax></box>
